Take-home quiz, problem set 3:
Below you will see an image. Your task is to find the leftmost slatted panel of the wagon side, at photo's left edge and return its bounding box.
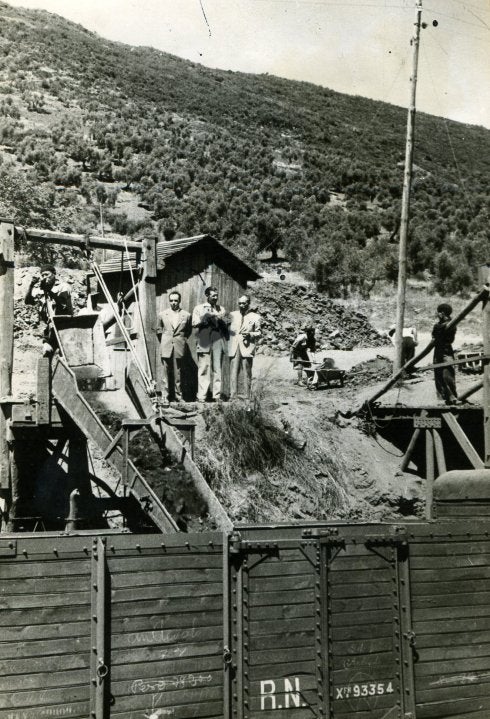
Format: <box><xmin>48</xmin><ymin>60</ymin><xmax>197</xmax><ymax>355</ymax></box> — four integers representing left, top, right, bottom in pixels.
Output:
<box><xmin>0</xmin><ymin>535</ymin><xmax>91</xmax><ymax>719</ymax></box>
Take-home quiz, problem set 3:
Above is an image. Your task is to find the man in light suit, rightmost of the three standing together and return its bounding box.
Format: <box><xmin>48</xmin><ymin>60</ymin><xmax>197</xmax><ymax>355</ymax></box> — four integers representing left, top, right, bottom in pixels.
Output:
<box><xmin>228</xmin><ymin>295</ymin><xmax>262</xmax><ymax>399</ymax></box>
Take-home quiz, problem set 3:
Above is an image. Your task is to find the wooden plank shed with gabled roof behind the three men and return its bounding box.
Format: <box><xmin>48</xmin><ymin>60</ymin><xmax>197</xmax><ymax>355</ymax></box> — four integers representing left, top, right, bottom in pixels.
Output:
<box><xmin>93</xmin><ymin>235</ymin><xmax>260</xmax><ymax>399</ymax></box>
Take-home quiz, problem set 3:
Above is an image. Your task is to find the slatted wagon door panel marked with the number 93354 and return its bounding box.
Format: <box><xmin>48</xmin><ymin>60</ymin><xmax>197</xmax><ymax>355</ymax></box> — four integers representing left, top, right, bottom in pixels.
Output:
<box><xmin>320</xmin><ymin>530</ymin><xmax>415</xmax><ymax>719</ymax></box>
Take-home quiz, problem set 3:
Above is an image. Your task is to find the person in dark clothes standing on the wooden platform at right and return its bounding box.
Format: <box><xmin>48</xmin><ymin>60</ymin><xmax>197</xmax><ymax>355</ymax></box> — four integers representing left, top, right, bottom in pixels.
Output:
<box><xmin>432</xmin><ymin>302</ymin><xmax>458</xmax><ymax>404</ymax></box>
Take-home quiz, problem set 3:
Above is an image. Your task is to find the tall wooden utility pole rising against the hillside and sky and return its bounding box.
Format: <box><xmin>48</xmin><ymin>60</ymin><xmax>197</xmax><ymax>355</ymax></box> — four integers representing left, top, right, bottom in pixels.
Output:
<box><xmin>393</xmin><ymin>0</ymin><xmax>422</xmax><ymax>374</ymax></box>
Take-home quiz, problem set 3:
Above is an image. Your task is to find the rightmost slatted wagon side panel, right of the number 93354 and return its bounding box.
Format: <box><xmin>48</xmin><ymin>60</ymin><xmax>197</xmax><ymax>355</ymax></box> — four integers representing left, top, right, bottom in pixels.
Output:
<box><xmin>410</xmin><ymin>523</ymin><xmax>490</xmax><ymax>719</ymax></box>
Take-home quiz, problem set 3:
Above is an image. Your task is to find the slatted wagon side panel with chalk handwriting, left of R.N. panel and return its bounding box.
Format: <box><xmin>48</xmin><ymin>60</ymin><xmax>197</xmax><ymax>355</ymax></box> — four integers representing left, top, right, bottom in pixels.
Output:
<box><xmin>106</xmin><ymin>535</ymin><xmax>223</xmax><ymax>719</ymax></box>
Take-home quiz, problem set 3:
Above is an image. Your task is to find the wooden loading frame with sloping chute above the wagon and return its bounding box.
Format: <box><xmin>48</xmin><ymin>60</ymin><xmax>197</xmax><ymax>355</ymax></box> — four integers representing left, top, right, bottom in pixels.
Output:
<box><xmin>0</xmin><ymin>220</ymin><xmax>231</xmax><ymax>532</ymax></box>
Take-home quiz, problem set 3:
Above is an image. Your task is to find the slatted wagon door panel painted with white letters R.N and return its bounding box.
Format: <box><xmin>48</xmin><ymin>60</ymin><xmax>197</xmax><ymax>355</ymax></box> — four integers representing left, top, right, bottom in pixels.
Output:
<box><xmin>231</xmin><ymin>541</ymin><xmax>322</xmax><ymax>719</ymax></box>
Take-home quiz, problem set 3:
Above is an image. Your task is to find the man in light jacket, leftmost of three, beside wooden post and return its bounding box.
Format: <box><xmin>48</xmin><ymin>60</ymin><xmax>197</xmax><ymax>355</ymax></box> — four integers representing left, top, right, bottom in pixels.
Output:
<box><xmin>157</xmin><ymin>292</ymin><xmax>191</xmax><ymax>402</ymax></box>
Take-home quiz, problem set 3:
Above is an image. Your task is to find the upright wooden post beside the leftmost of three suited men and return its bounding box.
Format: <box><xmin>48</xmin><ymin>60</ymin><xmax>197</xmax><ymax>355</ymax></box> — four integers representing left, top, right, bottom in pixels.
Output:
<box><xmin>138</xmin><ymin>237</ymin><xmax>157</xmax><ymax>379</ymax></box>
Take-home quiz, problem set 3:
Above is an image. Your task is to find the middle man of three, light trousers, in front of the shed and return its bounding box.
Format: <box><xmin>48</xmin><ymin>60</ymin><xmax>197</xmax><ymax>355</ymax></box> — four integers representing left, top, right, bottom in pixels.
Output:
<box><xmin>192</xmin><ymin>287</ymin><xmax>228</xmax><ymax>402</ymax></box>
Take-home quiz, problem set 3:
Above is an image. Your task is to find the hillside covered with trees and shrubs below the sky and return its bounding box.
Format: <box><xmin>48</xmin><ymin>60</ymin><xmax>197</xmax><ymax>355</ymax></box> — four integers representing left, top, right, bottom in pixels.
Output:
<box><xmin>0</xmin><ymin>2</ymin><xmax>490</xmax><ymax>296</ymax></box>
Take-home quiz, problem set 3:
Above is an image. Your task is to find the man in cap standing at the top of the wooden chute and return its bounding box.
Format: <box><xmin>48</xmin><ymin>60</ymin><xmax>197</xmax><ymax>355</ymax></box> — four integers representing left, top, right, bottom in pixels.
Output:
<box><xmin>24</xmin><ymin>265</ymin><xmax>73</xmax><ymax>357</ymax></box>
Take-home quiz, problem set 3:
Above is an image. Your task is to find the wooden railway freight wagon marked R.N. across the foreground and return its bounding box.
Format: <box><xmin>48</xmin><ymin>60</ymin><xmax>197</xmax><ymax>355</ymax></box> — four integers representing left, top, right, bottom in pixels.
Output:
<box><xmin>0</xmin><ymin>473</ymin><xmax>490</xmax><ymax>719</ymax></box>
